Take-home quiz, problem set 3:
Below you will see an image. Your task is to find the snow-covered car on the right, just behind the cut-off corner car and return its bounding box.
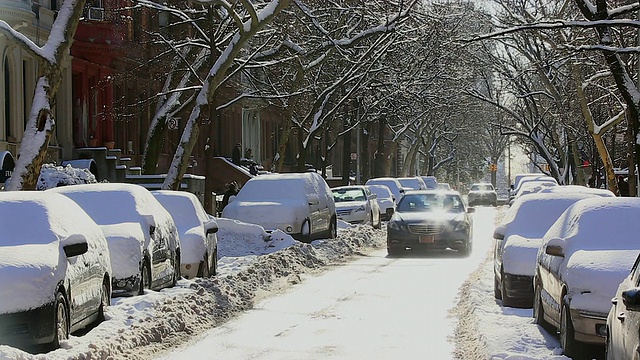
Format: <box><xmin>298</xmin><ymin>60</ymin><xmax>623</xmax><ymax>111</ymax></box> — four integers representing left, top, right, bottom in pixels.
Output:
<box><xmin>533</xmin><ymin>197</ymin><xmax>640</xmax><ymax>357</ymax></box>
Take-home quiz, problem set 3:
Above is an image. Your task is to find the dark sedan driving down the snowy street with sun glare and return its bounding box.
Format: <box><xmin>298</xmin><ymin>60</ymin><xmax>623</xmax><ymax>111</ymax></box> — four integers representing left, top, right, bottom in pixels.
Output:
<box><xmin>387</xmin><ymin>190</ymin><xmax>474</xmax><ymax>256</ymax></box>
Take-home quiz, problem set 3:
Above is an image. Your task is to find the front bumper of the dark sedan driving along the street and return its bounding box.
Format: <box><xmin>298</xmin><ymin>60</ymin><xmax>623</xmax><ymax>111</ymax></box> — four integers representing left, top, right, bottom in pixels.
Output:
<box><xmin>387</xmin><ymin>229</ymin><xmax>469</xmax><ymax>250</ymax></box>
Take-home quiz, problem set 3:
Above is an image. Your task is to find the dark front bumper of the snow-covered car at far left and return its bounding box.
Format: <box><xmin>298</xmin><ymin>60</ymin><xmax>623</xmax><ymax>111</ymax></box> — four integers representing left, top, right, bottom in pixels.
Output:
<box><xmin>0</xmin><ymin>303</ymin><xmax>55</xmax><ymax>345</ymax></box>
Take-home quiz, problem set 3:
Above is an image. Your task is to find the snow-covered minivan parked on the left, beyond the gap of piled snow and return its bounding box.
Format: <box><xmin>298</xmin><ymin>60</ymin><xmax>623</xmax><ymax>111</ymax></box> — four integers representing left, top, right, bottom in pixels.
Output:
<box><xmin>222</xmin><ymin>172</ymin><xmax>337</xmax><ymax>242</ymax></box>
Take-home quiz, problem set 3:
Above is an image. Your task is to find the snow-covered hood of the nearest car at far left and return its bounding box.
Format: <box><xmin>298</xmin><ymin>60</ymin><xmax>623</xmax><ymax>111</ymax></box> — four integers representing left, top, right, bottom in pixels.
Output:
<box><xmin>0</xmin><ymin>243</ymin><xmax>62</xmax><ymax>314</ymax></box>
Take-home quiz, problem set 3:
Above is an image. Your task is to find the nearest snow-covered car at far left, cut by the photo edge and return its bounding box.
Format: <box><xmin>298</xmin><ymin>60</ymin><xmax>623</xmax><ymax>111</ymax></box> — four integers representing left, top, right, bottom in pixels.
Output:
<box><xmin>0</xmin><ymin>191</ymin><xmax>111</xmax><ymax>348</ymax></box>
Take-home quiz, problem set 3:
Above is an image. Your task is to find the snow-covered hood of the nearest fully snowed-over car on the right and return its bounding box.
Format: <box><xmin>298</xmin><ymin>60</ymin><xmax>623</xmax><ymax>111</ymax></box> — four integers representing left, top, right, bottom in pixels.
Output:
<box><xmin>561</xmin><ymin>250</ymin><xmax>640</xmax><ymax>314</ymax></box>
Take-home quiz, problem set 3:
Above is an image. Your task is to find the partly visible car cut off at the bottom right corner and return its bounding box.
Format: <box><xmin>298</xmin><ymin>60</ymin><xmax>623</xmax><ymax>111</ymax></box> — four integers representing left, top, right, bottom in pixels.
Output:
<box><xmin>605</xmin><ymin>253</ymin><xmax>640</xmax><ymax>360</ymax></box>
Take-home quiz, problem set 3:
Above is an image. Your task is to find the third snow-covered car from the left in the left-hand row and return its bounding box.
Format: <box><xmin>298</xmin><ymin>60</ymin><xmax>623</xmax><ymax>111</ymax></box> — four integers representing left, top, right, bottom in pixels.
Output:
<box><xmin>151</xmin><ymin>190</ymin><xmax>218</xmax><ymax>279</ymax></box>
